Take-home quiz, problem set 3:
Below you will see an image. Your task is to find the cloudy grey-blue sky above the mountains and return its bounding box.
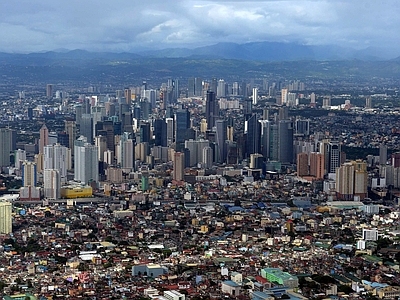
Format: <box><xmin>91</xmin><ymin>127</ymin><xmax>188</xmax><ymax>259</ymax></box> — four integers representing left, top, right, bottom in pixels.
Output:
<box><xmin>0</xmin><ymin>0</ymin><xmax>400</xmax><ymax>52</ymax></box>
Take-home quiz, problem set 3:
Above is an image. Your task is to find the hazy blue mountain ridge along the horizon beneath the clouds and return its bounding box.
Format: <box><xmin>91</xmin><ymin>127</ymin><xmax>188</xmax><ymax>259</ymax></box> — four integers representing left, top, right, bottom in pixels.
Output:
<box><xmin>0</xmin><ymin>42</ymin><xmax>400</xmax><ymax>65</ymax></box>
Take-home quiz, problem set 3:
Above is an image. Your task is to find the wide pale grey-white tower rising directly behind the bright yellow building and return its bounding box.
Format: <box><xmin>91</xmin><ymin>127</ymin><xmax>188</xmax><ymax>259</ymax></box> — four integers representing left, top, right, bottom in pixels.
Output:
<box><xmin>74</xmin><ymin>136</ymin><xmax>99</xmax><ymax>184</ymax></box>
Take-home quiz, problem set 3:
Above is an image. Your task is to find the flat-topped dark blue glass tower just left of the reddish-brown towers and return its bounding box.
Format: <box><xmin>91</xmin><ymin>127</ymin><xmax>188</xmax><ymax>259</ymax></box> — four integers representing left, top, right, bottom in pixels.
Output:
<box><xmin>278</xmin><ymin>120</ymin><xmax>294</xmax><ymax>164</ymax></box>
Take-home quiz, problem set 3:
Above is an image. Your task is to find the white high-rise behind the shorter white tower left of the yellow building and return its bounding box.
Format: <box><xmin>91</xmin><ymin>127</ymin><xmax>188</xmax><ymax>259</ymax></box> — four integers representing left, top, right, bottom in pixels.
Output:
<box><xmin>43</xmin><ymin>144</ymin><xmax>71</xmax><ymax>182</ymax></box>
